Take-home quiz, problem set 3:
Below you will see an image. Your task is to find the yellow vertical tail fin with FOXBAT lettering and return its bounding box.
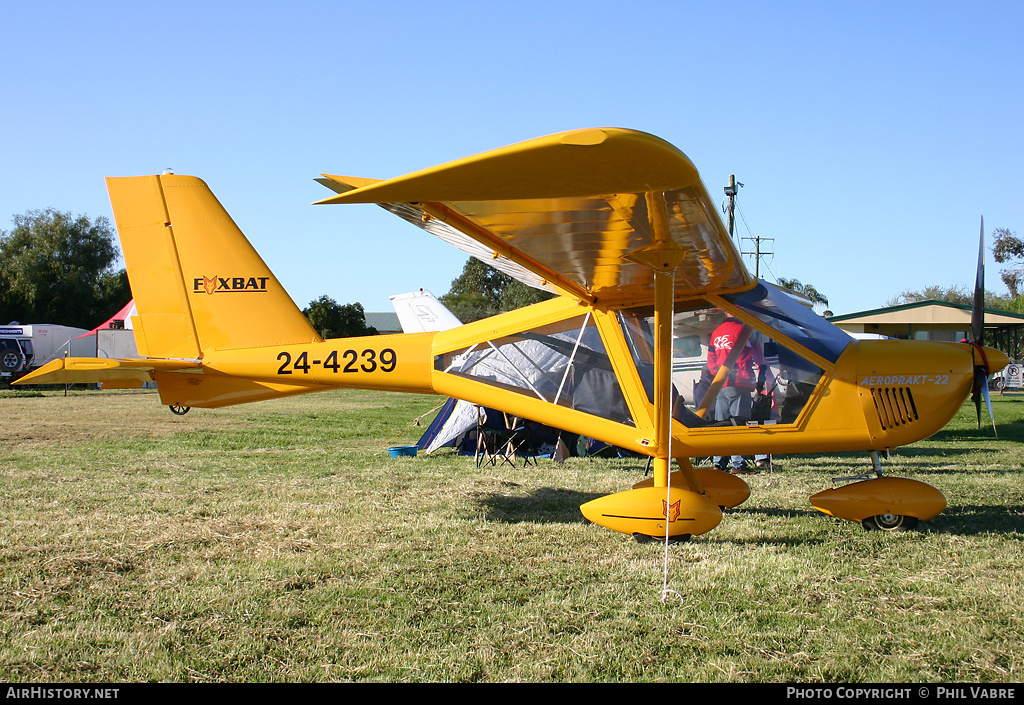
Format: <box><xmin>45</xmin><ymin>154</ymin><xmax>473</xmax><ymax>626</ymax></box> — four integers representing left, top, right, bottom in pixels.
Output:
<box><xmin>106</xmin><ymin>174</ymin><xmax>321</xmax><ymax>360</ymax></box>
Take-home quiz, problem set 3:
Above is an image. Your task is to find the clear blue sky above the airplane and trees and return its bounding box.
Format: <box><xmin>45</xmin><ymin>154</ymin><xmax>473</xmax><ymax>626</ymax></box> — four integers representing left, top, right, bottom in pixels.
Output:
<box><xmin>0</xmin><ymin>0</ymin><xmax>1024</xmax><ymax>314</ymax></box>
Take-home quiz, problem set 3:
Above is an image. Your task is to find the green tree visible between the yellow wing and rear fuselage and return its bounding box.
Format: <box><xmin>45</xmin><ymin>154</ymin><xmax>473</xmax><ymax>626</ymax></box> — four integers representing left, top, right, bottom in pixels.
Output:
<box><xmin>440</xmin><ymin>257</ymin><xmax>554</xmax><ymax>323</ymax></box>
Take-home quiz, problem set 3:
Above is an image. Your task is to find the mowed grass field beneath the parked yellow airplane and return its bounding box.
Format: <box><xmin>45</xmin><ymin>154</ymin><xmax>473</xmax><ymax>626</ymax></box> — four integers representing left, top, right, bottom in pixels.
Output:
<box><xmin>0</xmin><ymin>391</ymin><xmax>1024</xmax><ymax>682</ymax></box>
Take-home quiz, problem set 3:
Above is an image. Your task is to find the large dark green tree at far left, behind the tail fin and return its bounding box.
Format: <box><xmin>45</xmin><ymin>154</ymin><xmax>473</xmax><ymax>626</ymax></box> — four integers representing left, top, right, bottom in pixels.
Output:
<box><xmin>0</xmin><ymin>208</ymin><xmax>131</xmax><ymax>328</ymax></box>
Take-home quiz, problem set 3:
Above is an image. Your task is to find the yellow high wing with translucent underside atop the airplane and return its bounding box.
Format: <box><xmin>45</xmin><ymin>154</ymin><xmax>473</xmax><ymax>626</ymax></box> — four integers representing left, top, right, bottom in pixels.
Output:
<box><xmin>317</xmin><ymin>128</ymin><xmax>753</xmax><ymax>306</ymax></box>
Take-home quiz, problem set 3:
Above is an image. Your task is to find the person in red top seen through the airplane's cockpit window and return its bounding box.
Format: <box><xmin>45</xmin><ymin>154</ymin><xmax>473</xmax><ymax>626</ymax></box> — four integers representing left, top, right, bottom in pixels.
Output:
<box><xmin>708</xmin><ymin>316</ymin><xmax>768</xmax><ymax>473</ymax></box>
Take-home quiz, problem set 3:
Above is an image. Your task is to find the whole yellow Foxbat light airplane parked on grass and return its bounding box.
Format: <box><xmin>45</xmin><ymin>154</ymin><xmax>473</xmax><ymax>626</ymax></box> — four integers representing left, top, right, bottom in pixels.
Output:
<box><xmin>19</xmin><ymin>128</ymin><xmax>1008</xmax><ymax>540</ymax></box>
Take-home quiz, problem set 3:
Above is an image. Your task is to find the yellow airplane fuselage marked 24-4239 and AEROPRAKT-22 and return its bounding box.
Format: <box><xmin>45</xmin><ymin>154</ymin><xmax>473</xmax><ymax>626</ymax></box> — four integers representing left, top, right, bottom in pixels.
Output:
<box><xmin>157</xmin><ymin>286</ymin><xmax>1001</xmax><ymax>457</ymax></box>
